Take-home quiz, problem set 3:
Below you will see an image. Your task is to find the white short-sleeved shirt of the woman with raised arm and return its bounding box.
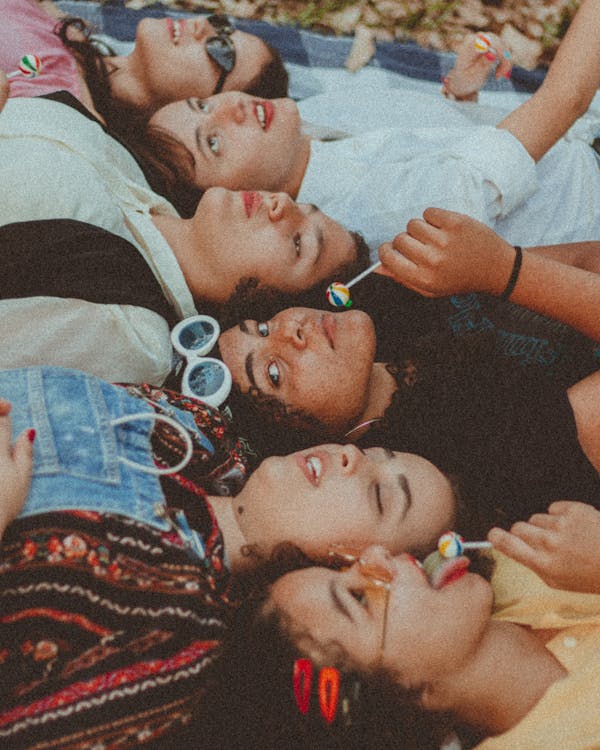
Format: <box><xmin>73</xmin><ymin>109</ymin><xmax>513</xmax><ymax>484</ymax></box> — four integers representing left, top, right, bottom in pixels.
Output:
<box><xmin>298</xmin><ymin>100</ymin><xmax>600</xmax><ymax>259</ymax></box>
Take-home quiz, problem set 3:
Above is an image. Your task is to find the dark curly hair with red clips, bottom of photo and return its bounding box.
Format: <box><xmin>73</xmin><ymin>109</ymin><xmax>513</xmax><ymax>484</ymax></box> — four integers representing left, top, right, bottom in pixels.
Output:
<box><xmin>180</xmin><ymin>589</ymin><xmax>452</xmax><ymax>750</ymax></box>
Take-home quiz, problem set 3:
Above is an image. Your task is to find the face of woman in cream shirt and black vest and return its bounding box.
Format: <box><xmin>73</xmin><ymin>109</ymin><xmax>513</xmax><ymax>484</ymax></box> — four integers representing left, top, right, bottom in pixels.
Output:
<box><xmin>190</xmin><ymin>188</ymin><xmax>357</xmax><ymax>302</ymax></box>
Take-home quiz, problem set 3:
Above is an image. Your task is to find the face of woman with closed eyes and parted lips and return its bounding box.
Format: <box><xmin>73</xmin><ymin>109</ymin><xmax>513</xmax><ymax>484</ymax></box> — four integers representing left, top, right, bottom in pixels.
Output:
<box><xmin>233</xmin><ymin>445</ymin><xmax>455</xmax><ymax>560</ymax></box>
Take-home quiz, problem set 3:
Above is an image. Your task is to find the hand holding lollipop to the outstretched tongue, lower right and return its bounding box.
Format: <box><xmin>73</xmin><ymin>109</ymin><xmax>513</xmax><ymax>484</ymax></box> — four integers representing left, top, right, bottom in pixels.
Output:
<box><xmin>488</xmin><ymin>500</ymin><xmax>600</xmax><ymax>594</ymax></box>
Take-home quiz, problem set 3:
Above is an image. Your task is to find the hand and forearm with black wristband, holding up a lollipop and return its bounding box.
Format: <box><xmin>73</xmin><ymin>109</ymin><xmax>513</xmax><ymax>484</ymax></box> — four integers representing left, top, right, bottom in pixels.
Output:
<box><xmin>379</xmin><ymin>208</ymin><xmax>600</xmax><ymax>341</ymax></box>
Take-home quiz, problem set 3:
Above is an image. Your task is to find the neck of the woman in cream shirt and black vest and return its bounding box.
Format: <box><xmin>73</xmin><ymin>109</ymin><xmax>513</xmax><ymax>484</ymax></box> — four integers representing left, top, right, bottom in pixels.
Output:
<box><xmin>152</xmin><ymin>214</ymin><xmax>223</xmax><ymax>302</ymax></box>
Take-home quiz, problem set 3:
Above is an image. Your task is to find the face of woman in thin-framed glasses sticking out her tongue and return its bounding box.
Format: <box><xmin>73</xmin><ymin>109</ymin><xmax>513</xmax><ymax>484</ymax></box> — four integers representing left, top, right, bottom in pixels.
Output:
<box><xmin>270</xmin><ymin>547</ymin><xmax>492</xmax><ymax>687</ymax></box>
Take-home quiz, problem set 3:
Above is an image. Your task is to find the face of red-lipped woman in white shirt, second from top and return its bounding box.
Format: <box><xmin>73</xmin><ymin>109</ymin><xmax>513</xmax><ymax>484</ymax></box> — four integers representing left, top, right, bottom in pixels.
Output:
<box><xmin>151</xmin><ymin>92</ymin><xmax>309</xmax><ymax>192</ymax></box>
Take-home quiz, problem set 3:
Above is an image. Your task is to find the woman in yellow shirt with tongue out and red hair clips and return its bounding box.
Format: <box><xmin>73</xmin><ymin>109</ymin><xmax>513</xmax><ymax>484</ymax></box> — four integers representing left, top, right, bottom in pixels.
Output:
<box><xmin>190</xmin><ymin>547</ymin><xmax>600</xmax><ymax>750</ymax></box>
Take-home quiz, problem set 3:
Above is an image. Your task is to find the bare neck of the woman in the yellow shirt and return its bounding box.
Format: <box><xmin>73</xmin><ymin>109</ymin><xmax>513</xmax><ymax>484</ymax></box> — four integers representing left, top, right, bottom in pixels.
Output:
<box><xmin>428</xmin><ymin>621</ymin><xmax>566</xmax><ymax>735</ymax></box>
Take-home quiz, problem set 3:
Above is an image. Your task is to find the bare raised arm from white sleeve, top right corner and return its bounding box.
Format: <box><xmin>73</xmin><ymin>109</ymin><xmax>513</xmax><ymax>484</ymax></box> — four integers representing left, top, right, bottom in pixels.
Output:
<box><xmin>498</xmin><ymin>0</ymin><xmax>600</xmax><ymax>161</ymax></box>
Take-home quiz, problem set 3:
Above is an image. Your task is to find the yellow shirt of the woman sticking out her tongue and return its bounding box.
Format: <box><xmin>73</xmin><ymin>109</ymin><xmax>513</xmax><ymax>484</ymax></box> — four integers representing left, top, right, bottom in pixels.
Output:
<box><xmin>477</xmin><ymin>554</ymin><xmax>600</xmax><ymax>750</ymax></box>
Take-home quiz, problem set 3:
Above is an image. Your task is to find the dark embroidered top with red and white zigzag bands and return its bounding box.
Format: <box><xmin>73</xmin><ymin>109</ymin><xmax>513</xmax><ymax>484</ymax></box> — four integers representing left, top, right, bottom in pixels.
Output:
<box><xmin>0</xmin><ymin>512</ymin><xmax>230</xmax><ymax>750</ymax></box>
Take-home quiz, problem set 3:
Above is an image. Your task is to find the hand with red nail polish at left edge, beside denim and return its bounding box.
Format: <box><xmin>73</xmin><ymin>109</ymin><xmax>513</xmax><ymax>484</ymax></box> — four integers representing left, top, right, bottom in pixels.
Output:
<box><xmin>0</xmin><ymin>398</ymin><xmax>35</xmax><ymax>539</ymax></box>
